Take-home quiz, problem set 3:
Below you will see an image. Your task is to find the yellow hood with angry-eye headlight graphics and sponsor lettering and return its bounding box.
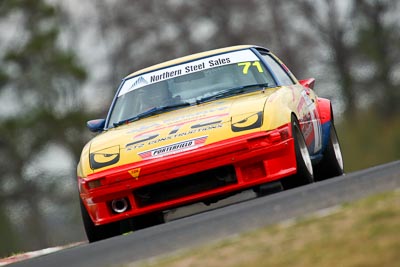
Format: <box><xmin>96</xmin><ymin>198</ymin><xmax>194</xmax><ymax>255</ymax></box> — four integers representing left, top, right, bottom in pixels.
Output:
<box><xmin>89</xmin><ymin>90</ymin><xmax>274</xmax><ymax>171</ymax></box>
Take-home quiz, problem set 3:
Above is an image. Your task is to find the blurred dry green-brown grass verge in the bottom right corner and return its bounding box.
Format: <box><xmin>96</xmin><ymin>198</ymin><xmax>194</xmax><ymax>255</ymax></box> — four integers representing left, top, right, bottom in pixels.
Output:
<box><xmin>124</xmin><ymin>190</ymin><xmax>400</xmax><ymax>267</ymax></box>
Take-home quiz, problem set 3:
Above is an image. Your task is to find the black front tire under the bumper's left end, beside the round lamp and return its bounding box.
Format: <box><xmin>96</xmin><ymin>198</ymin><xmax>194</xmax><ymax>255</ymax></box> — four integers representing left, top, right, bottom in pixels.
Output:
<box><xmin>79</xmin><ymin>198</ymin><xmax>121</xmax><ymax>243</ymax></box>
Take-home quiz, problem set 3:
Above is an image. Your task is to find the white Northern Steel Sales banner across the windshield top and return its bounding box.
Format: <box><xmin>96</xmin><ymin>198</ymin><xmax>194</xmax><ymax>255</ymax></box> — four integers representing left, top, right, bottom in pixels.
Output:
<box><xmin>118</xmin><ymin>49</ymin><xmax>260</xmax><ymax>97</ymax></box>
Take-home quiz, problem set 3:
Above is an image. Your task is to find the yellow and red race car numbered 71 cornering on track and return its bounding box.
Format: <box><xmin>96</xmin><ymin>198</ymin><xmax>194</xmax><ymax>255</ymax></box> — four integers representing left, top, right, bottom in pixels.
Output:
<box><xmin>77</xmin><ymin>45</ymin><xmax>343</xmax><ymax>242</ymax></box>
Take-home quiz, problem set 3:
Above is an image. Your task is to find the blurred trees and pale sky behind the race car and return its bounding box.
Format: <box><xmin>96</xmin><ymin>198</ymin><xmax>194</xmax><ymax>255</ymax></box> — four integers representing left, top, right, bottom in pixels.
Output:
<box><xmin>0</xmin><ymin>0</ymin><xmax>400</xmax><ymax>256</ymax></box>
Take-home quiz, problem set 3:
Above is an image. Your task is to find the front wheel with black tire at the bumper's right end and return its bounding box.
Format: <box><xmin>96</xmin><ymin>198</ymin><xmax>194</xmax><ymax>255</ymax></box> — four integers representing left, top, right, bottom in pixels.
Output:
<box><xmin>282</xmin><ymin>116</ymin><xmax>314</xmax><ymax>189</ymax></box>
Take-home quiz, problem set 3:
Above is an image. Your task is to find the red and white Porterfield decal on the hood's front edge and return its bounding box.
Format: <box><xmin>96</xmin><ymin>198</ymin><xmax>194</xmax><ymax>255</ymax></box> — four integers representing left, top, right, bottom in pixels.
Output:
<box><xmin>138</xmin><ymin>136</ymin><xmax>207</xmax><ymax>159</ymax></box>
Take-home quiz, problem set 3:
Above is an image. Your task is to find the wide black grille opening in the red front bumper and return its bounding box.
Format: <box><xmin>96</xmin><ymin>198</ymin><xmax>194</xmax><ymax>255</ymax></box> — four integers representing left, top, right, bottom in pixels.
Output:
<box><xmin>133</xmin><ymin>166</ymin><xmax>237</xmax><ymax>207</ymax></box>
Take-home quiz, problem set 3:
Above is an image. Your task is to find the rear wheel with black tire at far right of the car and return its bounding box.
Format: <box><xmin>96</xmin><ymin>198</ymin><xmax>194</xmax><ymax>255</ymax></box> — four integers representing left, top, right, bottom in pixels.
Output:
<box><xmin>315</xmin><ymin>123</ymin><xmax>344</xmax><ymax>181</ymax></box>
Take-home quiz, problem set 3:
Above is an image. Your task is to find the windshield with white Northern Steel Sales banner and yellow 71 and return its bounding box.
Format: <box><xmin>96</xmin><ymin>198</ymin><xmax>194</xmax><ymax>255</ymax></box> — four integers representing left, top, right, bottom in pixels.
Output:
<box><xmin>108</xmin><ymin>50</ymin><xmax>275</xmax><ymax>127</ymax></box>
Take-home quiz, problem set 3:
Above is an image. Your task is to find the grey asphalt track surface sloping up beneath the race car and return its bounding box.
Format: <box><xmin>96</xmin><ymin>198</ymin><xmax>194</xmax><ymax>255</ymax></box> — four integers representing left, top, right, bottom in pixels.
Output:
<box><xmin>7</xmin><ymin>161</ymin><xmax>400</xmax><ymax>267</ymax></box>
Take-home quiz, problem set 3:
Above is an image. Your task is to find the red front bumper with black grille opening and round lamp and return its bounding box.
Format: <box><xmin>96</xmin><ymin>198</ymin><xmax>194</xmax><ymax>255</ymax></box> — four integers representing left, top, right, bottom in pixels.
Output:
<box><xmin>79</xmin><ymin>124</ymin><xmax>296</xmax><ymax>225</ymax></box>
